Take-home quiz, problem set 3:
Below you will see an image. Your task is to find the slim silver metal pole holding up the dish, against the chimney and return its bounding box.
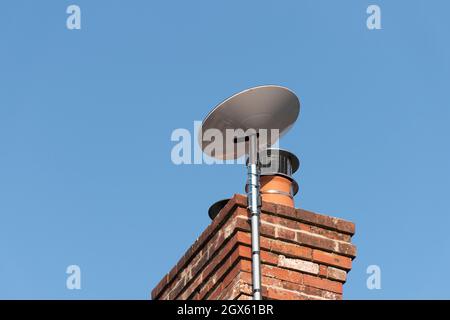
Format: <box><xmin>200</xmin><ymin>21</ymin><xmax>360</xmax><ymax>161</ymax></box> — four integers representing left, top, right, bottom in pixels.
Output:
<box><xmin>247</xmin><ymin>134</ymin><xmax>262</xmax><ymax>300</ymax></box>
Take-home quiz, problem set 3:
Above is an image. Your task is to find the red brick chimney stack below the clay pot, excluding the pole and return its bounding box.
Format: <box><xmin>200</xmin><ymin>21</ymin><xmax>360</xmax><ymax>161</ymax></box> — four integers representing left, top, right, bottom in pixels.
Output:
<box><xmin>151</xmin><ymin>195</ymin><xmax>356</xmax><ymax>300</ymax></box>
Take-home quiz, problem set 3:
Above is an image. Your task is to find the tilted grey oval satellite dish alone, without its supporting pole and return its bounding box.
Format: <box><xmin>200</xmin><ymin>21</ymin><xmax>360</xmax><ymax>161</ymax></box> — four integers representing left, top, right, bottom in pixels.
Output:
<box><xmin>198</xmin><ymin>85</ymin><xmax>300</xmax><ymax>160</ymax></box>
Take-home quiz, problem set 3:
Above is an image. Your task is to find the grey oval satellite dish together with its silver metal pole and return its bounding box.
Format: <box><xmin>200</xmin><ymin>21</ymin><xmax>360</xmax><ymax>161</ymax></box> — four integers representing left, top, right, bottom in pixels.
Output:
<box><xmin>198</xmin><ymin>85</ymin><xmax>300</xmax><ymax>300</ymax></box>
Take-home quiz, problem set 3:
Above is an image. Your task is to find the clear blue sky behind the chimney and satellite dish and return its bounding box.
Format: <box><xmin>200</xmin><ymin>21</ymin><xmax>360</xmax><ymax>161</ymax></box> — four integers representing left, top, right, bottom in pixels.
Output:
<box><xmin>0</xmin><ymin>0</ymin><xmax>450</xmax><ymax>299</ymax></box>
